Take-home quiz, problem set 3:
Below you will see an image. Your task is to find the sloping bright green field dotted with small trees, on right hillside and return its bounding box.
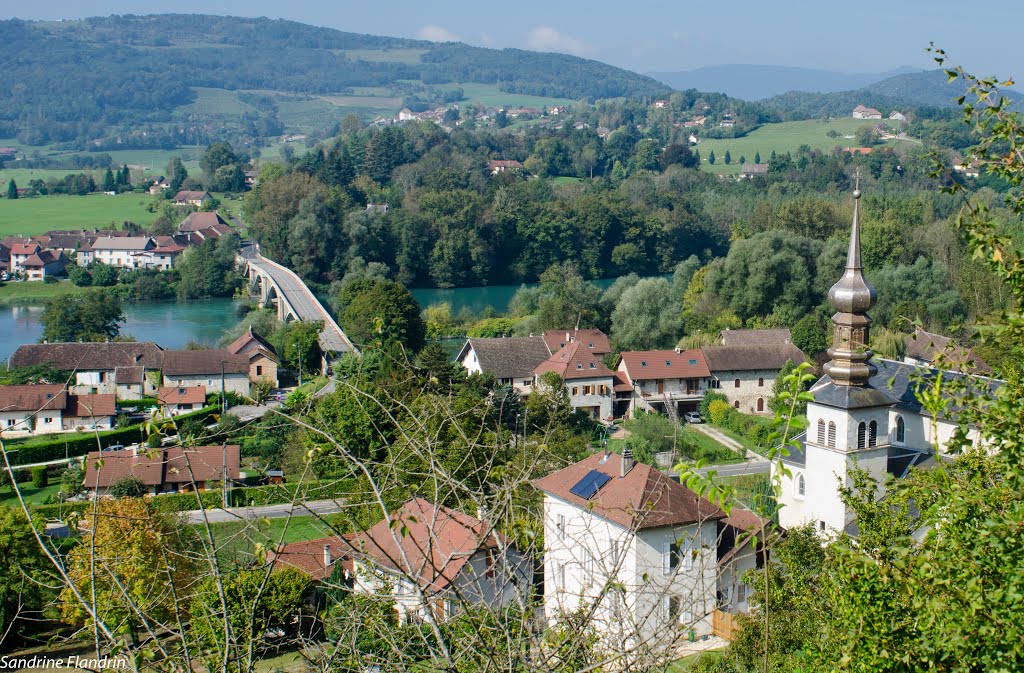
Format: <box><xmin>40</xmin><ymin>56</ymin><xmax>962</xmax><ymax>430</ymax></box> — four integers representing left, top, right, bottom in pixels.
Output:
<box><xmin>696</xmin><ymin>118</ymin><xmax>911</xmax><ymax>175</ymax></box>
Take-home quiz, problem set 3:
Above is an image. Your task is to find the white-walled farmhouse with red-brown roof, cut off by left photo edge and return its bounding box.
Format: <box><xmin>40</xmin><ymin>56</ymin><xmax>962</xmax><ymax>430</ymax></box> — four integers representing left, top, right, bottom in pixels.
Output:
<box><xmin>0</xmin><ymin>384</ymin><xmax>116</xmax><ymax>436</ymax></box>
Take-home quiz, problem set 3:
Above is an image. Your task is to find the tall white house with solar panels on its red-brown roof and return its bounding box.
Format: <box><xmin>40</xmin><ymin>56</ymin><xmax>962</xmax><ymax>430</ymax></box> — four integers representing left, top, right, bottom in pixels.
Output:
<box><xmin>535</xmin><ymin>451</ymin><xmax>725</xmax><ymax>659</ymax></box>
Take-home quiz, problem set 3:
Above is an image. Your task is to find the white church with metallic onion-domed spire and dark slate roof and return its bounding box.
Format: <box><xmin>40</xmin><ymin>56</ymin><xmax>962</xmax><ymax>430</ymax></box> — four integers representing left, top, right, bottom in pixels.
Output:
<box><xmin>773</xmin><ymin>188</ymin><xmax>998</xmax><ymax>536</ymax></box>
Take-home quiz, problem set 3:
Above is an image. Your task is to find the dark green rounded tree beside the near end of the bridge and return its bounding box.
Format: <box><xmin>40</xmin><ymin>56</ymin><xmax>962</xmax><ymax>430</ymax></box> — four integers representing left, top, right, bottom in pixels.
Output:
<box><xmin>338</xmin><ymin>279</ymin><xmax>426</xmax><ymax>352</ymax></box>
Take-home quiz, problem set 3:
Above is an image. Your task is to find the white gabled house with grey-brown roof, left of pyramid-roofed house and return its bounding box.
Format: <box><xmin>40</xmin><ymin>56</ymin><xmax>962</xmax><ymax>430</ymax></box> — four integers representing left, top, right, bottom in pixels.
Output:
<box><xmin>456</xmin><ymin>336</ymin><xmax>551</xmax><ymax>395</ymax></box>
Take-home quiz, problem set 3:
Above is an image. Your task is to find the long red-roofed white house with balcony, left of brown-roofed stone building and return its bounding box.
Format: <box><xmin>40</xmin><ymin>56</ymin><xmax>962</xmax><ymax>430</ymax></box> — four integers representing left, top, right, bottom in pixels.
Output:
<box><xmin>618</xmin><ymin>348</ymin><xmax>711</xmax><ymax>416</ymax></box>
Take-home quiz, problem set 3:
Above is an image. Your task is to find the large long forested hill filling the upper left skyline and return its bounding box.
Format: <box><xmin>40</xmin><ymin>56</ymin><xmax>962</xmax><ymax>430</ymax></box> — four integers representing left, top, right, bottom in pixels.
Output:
<box><xmin>0</xmin><ymin>14</ymin><xmax>669</xmax><ymax>143</ymax></box>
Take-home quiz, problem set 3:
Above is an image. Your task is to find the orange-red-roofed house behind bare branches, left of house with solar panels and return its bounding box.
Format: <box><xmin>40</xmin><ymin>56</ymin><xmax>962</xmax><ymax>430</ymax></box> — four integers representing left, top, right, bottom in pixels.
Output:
<box><xmin>275</xmin><ymin>498</ymin><xmax>532</xmax><ymax>623</ymax></box>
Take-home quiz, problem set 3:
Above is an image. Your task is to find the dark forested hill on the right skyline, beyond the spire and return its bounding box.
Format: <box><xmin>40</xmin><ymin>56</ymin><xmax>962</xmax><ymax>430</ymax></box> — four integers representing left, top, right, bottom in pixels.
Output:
<box><xmin>763</xmin><ymin>70</ymin><xmax>1024</xmax><ymax>119</ymax></box>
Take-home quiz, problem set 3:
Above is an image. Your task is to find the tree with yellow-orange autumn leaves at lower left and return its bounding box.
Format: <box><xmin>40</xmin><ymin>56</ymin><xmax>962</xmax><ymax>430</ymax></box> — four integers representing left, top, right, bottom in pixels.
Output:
<box><xmin>60</xmin><ymin>498</ymin><xmax>197</xmax><ymax>642</ymax></box>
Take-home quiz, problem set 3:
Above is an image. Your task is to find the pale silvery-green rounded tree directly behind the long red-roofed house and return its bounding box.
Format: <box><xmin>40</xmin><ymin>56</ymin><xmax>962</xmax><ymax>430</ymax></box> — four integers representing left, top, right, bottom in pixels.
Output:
<box><xmin>611</xmin><ymin>278</ymin><xmax>682</xmax><ymax>350</ymax></box>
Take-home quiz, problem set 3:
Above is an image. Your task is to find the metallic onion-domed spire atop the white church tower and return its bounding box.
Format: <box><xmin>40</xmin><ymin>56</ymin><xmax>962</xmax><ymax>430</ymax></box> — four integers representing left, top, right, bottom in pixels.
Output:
<box><xmin>824</xmin><ymin>176</ymin><xmax>878</xmax><ymax>386</ymax></box>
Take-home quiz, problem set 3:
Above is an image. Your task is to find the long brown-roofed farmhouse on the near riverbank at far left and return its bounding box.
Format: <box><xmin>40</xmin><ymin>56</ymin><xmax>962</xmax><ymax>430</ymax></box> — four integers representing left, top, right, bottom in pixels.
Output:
<box><xmin>8</xmin><ymin>341</ymin><xmax>164</xmax><ymax>399</ymax></box>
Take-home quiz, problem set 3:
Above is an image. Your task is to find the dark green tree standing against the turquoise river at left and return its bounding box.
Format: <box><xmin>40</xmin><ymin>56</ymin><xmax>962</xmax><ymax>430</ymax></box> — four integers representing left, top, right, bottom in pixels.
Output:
<box><xmin>39</xmin><ymin>289</ymin><xmax>125</xmax><ymax>342</ymax></box>
